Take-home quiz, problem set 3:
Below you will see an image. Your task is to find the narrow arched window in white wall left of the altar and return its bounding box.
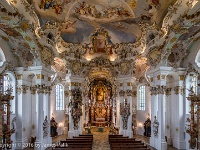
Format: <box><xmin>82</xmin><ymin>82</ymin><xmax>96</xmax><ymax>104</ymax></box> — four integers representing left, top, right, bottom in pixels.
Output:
<box><xmin>56</xmin><ymin>84</ymin><xmax>64</xmax><ymax>110</ymax></box>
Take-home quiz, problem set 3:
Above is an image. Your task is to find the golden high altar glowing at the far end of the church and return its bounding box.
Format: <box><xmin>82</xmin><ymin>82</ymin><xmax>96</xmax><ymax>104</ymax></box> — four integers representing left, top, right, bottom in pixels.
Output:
<box><xmin>89</xmin><ymin>81</ymin><xmax>112</xmax><ymax>126</ymax></box>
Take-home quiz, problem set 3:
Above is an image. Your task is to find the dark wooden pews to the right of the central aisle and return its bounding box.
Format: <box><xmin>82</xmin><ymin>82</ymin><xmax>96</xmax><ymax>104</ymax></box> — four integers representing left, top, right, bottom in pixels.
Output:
<box><xmin>108</xmin><ymin>135</ymin><xmax>150</xmax><ymax>150</ymax></box>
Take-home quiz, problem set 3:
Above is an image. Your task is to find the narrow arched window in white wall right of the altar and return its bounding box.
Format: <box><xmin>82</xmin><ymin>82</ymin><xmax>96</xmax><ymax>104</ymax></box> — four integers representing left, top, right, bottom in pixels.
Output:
<box><xmin>138</xmin><ymin>85</ymin><xmax>145</xmax><ymax>110</ymax></box>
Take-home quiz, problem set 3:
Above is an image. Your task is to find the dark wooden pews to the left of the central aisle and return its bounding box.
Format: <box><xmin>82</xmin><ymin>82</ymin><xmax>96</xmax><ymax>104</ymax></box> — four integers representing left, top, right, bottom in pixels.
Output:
<box><xmin>55</xmin><ymin>134</ymin><xmax>93</xmax><ymax>150</ymax></box>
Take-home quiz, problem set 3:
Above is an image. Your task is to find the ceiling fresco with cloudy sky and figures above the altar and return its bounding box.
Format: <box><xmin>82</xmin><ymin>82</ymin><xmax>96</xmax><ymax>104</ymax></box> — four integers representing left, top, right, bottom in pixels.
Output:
<box><xmin>33</xmin><ymin>0</ymin><xmax>170</xmax><ymax>43</ymax></box>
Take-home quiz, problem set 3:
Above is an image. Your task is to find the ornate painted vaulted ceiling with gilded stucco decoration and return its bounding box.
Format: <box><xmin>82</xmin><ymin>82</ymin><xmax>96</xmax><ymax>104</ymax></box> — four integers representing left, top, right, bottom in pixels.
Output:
<box><xmin>0</xmin><ymin>0</ymin><xmax>200</xmax><ymax>84</ymax></box>
